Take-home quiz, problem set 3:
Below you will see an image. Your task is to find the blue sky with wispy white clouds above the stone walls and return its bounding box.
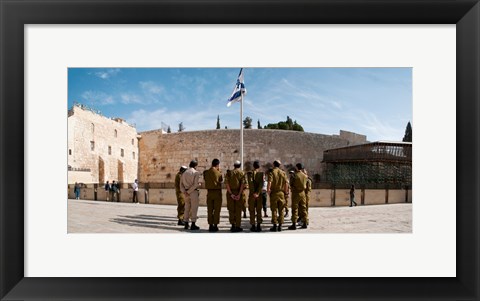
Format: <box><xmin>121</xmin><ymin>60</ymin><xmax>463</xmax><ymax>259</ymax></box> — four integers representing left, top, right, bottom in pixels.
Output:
<box><xmin>68</xmin><ymin>68</ymin><xmax>414</xmax><ymax>141</ymax></box>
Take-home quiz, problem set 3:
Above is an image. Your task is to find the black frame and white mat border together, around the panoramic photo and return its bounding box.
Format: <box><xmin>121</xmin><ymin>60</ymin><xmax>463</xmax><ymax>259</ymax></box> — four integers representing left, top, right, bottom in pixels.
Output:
<box><xmin>0</xmin><ymin>0</ymin><xmax>480</xmax><ymax>300</ymax></box>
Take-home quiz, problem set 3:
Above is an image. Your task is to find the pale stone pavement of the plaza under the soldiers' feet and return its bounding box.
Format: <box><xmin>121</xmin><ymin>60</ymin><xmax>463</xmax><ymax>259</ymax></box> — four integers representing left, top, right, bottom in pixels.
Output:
<box><xmin>68</xmin><ymin>199</ymin><xmax>412</xmax><ymax>235</ymax></box>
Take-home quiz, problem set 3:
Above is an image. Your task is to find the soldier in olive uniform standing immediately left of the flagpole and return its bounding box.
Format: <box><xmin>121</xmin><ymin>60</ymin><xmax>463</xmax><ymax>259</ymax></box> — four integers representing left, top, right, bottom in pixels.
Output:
<box><xmin>225</xmin><ymin>161</ymin><xmax>246</xmax><ymax>232</ymax></box>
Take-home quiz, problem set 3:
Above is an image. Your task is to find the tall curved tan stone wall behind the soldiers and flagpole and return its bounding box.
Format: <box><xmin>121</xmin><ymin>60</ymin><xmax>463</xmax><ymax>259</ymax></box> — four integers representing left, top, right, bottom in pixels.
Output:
<box><xmin>135</xmin><ymin>129</ymin><xmax>366</xmax><ymax>183</ymax></box>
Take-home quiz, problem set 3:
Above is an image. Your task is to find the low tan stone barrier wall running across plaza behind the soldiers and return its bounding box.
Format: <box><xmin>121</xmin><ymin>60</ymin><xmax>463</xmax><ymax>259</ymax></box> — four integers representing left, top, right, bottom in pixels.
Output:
<box><xmin>68</xmin><ymin>185</ymin><xmax>412</xmax><ymax>207</ymax></box>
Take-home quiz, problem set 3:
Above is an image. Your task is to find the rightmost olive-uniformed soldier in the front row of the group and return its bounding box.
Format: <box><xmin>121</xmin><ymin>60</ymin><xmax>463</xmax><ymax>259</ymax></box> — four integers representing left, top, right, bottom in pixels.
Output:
<box><xmin>288</xmin><ymin>163</ymin><xmax>308</xmax><ymax>230</ymax></box>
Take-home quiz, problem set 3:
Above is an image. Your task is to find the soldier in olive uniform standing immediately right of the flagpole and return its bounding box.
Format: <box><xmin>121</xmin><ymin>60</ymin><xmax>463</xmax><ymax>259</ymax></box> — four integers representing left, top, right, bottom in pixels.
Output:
<box><xmin>247</xmin><ymin>161</ymin><xmax>263</xmax><ymax>232</ymax></box>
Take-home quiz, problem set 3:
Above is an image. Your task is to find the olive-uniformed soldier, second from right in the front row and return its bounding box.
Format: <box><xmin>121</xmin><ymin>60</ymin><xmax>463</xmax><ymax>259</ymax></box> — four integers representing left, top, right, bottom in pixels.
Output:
<box><xmin>267</xmin><ymin>160</ymin><xmax>288</xmax><ymax>232</ymax></box>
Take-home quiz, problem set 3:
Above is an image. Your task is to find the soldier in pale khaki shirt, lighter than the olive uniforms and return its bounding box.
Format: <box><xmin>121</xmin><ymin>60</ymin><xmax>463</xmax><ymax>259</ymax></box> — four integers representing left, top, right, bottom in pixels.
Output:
<box><xmin>180</xmin><ymin>160</ymin><xmax>200</xmax><ymax>230</ymax></box>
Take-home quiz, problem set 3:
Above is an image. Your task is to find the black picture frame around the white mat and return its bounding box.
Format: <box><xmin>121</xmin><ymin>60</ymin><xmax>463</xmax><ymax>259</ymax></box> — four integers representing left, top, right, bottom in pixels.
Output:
<box><xmin>0</xmin><ymin>0</ymin><xmax>480</xmax><ymax>300</ymax></box>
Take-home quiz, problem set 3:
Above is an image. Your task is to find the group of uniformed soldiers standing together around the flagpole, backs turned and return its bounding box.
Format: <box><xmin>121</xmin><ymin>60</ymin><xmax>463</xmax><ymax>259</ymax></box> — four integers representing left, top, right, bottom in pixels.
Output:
<box><xmin>175</xmin><ymin>159</ymin><xmax>312</xmax><ymax>232</ymax></box>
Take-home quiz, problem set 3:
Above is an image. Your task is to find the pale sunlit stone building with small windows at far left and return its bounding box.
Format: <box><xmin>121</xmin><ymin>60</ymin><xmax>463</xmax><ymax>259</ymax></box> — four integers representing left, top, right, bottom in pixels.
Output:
<box><xmin>67</xmin><ymin>105</ymin><xmax>139</xmax><ymax>184</ymax></box>
